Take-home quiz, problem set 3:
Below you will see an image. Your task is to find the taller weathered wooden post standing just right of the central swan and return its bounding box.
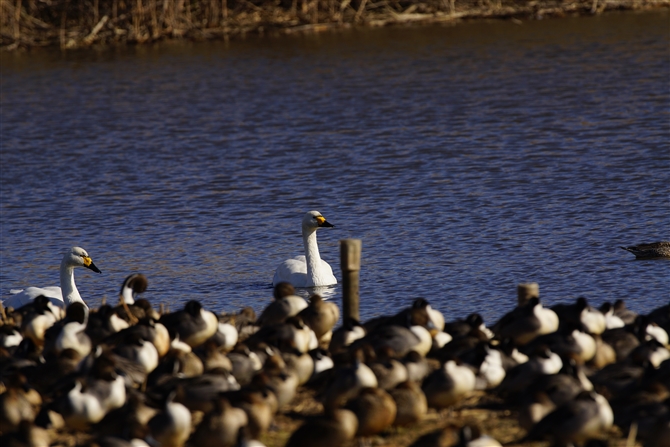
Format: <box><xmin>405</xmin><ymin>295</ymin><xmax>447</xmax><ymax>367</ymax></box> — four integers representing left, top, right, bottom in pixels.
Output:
<box><xmin>340</xmin><ymin>239</ymin><xmax>363</xmax><ymax>321</ymax></box>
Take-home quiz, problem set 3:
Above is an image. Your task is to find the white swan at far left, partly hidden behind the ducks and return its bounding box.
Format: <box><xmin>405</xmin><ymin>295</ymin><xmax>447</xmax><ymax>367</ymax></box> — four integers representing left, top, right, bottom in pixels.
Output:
<box><xmin>2</xmin><ymin>247</ymin><xmax>101</xmax><ymax>309</ymax></box>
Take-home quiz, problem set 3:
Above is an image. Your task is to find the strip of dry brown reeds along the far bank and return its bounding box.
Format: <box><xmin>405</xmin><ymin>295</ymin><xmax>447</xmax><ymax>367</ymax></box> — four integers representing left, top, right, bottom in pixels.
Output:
<box><xmin>0</xmin><ymin>0</ymin><xmax>670</xmax><ymax>50</ymax></box>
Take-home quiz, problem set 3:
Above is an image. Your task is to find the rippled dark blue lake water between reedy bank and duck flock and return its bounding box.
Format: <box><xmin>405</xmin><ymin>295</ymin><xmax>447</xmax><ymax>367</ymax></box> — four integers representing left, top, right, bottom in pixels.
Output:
<box><xmin>0</xmin><ymin>10</ymin><xmax>670</xmax><ymax>322</ymax></box>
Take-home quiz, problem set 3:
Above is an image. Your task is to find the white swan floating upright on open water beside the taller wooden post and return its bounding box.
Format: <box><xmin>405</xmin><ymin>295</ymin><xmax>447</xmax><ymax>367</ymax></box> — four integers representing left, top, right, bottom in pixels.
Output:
<box><xmin>272</xmin><ymin>211</ymin><xmax>337</xmax><ymax>287</ymax></box>
